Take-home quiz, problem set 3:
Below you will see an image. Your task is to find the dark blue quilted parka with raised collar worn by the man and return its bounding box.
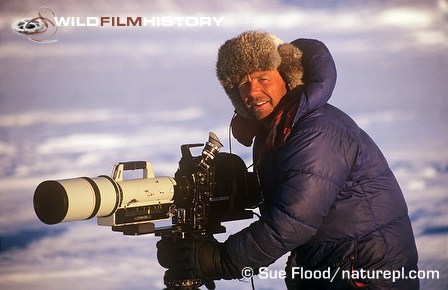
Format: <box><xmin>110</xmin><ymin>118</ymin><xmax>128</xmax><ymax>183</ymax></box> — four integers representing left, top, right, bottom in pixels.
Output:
<box><xmin>225</xmin><ymin>39</ymin><xmax>419</xmax><ymax>290</ymax></box>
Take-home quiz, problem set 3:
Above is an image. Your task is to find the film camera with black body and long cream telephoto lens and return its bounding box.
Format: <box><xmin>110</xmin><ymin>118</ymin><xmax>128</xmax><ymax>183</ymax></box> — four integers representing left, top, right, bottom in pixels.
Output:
<box><xmin>33</xmin><ymin>132</ymin><xmax>262</xmax><ymax>289</ymax></box>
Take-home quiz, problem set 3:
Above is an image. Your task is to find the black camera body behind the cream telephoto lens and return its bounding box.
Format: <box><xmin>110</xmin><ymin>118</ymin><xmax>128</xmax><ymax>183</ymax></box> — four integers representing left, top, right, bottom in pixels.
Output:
<box><xmin>167</xmin><ymin>144</ymin><xmax>262</xmax><ymax>235</ymax></box>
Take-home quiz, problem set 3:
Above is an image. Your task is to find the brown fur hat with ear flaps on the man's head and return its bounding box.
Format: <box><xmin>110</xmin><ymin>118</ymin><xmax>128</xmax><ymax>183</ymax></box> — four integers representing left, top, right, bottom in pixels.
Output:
<box><xmin>216</xmin><ymin>31</ymin><xmax>303</xmax><ymax>119</ymax></box>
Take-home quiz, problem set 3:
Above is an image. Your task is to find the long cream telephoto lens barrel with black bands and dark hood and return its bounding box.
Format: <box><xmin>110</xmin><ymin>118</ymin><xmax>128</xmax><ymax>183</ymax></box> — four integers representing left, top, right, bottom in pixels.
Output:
<box><xmin>33</xmin><ymin>175</ymin><xmax>176</xmax><ymax>225</ymax></box>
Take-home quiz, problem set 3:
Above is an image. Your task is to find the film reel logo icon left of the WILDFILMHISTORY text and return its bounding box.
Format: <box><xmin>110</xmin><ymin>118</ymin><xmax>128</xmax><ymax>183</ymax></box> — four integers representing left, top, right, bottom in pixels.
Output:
<box><xmin>11</xmin><ymin>6</ymin><xmax>58</xmax><ymax>43</ymax></box>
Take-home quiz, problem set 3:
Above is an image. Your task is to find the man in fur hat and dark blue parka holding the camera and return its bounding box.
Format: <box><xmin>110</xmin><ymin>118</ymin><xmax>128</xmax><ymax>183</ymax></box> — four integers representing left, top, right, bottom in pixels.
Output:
<box><xmin>158</xmin><ymin>32</ymin><xmax>419</xmax><ymax>290</ymax></box>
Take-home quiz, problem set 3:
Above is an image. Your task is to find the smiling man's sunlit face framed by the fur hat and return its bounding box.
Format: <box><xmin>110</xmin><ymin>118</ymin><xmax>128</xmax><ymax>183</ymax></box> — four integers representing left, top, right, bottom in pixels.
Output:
<box><xmin>238</xmin><ymin>70</ymin><xmax>287</xmax><ymax>121</ymax></box>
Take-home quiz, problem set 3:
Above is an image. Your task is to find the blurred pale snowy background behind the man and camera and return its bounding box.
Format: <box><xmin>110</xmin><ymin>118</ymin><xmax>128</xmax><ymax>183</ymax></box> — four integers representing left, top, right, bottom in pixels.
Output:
<box><xmin>0</xmin><ymin>0</ymin><xmax>448</xmax><ymax>290</ymax></box>
